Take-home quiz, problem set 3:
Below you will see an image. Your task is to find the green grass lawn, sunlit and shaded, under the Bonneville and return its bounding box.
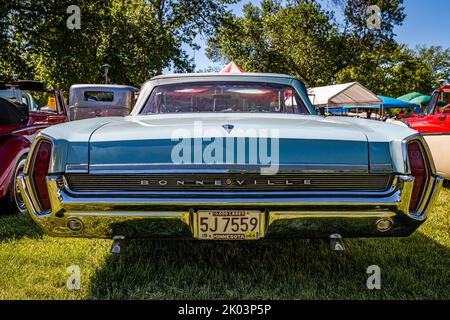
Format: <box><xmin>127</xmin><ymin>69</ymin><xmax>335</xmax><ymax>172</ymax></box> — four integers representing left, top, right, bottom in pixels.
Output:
<box><xmin>0</xmin><ymin>184</ymin><xmax>450</xmax><ymax>299</ymax></box>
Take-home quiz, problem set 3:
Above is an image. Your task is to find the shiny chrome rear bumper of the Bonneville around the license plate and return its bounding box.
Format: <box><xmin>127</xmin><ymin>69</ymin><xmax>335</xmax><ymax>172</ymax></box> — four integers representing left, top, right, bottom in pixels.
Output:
<box><xmin>19</xmin><ymin>175</ymin><xmax>443</xmax><ymax>239</ymax></box>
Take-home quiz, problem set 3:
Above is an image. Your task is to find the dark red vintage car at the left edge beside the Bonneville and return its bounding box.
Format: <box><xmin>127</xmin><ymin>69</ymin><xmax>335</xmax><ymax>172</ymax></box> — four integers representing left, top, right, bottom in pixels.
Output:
<box><xmin>0</xmin><ymin>81</ymin><xmax>69</xmax><ymax>213</ymax></box>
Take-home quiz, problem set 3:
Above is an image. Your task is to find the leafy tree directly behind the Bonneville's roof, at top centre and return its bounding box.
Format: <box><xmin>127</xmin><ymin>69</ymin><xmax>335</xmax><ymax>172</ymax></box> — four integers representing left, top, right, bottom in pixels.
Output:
<box><xmin>206</xmin><ymin>0</ymin><xmax>340</xmax><ymax>85</ymax></box>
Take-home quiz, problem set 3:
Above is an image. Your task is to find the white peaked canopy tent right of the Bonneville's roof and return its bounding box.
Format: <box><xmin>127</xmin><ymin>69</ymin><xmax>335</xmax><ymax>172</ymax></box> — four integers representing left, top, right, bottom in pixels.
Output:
<box><xmin>308</xmin><ymin>82</ymin><xmax>383</xmax><ymax>108</ymax></box>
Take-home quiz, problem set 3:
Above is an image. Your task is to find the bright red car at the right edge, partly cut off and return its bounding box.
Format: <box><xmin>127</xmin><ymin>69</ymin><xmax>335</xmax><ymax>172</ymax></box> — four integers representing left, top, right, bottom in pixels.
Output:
<box><xmin>404</xmin><ymin>86</ymin><xmax>450</xmax><ymax>135</ymax></box>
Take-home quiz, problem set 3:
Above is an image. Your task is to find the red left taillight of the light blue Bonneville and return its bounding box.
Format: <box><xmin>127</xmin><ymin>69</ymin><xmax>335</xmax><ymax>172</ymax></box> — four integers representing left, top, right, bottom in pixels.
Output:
<box><xmin>32</xmin><ymin>141</ymin><xmax>52</xmax><ymax>211</ymax></box>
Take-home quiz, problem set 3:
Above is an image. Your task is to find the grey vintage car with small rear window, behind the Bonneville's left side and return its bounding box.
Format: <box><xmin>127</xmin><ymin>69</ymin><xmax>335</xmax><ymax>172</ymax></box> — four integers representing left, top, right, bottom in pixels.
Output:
<box><xmin>69</xmin><ymin>84</ymin><xmax>138</xmax><ymax>121</ymax></box>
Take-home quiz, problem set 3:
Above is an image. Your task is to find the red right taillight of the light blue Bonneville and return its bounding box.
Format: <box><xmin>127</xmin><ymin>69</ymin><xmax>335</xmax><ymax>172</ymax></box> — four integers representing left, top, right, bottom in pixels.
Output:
<box><xmin>408</xmin><ymin>141</ymin><xmax>429</xmax><ymax>212</ymax></box>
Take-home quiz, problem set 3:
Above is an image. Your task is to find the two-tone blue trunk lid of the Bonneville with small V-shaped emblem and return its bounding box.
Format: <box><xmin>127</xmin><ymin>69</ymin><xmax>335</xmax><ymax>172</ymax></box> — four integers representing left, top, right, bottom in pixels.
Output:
<box><xmin>89</xmin><ymin>114</ymin><xmax>369</xmax><ymax>171</ymax></box>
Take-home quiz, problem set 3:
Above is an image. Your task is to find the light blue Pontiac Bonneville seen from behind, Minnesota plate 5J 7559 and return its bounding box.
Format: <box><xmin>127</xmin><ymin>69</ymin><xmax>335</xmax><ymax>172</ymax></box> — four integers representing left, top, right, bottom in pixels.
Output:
<box><xmin>19</xmin><ymin>73</ymin><xmax>442</xmax><ymax>248</ymax></box>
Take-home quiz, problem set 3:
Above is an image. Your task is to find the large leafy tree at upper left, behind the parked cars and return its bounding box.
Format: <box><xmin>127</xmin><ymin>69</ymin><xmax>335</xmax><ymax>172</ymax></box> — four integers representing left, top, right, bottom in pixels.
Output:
<box><xmin>0</xmin><ymin>0</ymin><xmax>235</xmax><ymax>90</ymax></box>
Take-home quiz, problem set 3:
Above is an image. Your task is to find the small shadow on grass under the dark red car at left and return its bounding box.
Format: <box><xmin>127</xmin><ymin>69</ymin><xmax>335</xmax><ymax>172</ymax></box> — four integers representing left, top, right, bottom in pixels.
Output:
<box><xmin>0</xmin><ymin>214</ymin><xmax>43</xmax><ymax>242</ymax></box>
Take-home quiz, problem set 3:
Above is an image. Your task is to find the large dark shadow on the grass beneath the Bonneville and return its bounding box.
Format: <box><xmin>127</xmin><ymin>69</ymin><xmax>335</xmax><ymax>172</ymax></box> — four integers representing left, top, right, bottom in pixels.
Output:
<box><xmin>90</xmin><ymin>232</ymin><xmax>450</xmax><ymax>299</ymax></box>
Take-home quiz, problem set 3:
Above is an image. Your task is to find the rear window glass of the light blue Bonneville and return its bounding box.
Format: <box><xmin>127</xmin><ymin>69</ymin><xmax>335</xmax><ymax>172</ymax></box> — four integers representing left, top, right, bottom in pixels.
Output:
<box><xmin>141</xmin><ymin>82</ymin><xmax>309</xmax><ymax>114</ymax></box>
